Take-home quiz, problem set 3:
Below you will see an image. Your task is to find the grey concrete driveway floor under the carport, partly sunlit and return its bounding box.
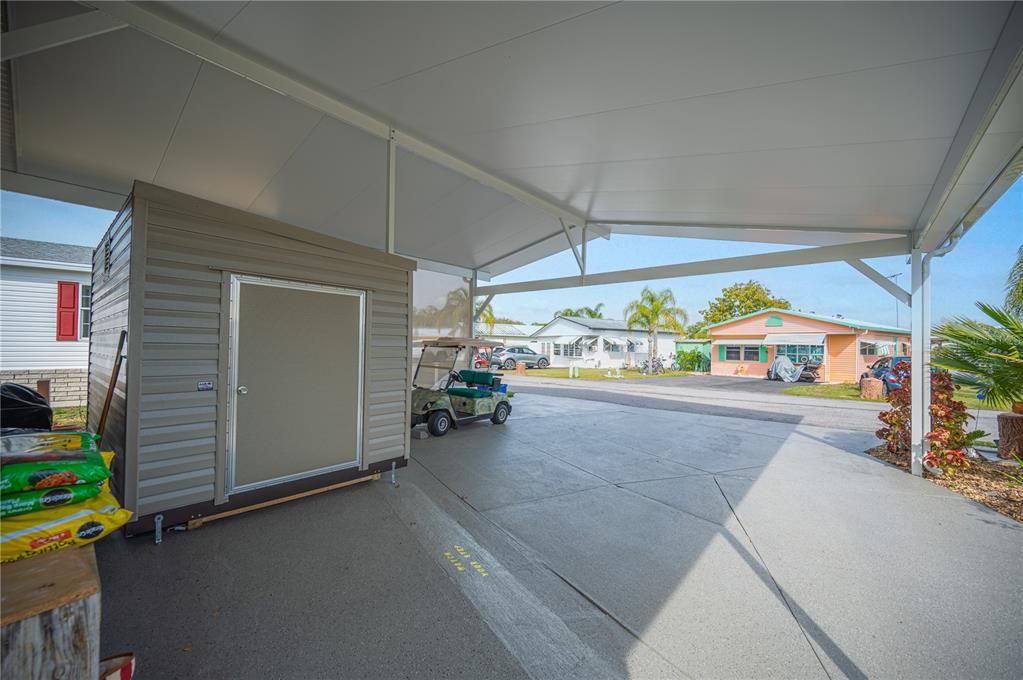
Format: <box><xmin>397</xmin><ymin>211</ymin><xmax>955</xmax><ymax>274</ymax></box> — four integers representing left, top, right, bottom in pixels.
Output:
<box><xmin>98</xmin><ymin>394</ymin><xmax>1023</xmax><ymax>679</ymax></box>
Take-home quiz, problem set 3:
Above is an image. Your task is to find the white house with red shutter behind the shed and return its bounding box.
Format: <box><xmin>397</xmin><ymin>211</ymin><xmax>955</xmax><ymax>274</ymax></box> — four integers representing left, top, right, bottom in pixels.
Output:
<box><xmin>0</xmin><ymin>237</ymin><xmax>92</xmax><ymax>406</ymax></box>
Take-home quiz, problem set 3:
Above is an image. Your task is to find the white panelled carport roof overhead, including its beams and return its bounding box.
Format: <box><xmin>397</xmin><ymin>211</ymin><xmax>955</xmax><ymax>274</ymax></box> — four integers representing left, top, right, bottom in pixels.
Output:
<box><xmin>3</xmin><ymin>2</ymin><xmax>1023</xmax><ymax>278</ymax></box>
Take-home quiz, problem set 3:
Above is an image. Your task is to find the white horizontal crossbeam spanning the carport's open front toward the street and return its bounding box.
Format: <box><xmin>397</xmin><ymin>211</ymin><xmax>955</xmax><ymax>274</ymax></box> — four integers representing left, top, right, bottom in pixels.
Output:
<box><xmin>477</xmin><ymin>237</ymin><xmax>909</xmax><ymax>296</ymax></box>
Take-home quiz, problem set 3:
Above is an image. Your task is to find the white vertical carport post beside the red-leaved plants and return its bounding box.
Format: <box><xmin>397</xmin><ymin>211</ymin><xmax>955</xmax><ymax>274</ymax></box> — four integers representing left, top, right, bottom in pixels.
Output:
<box><xmin>909</xmin><ymin>248</ymin><xmax>931</xmax><ymax>477</ymax></box>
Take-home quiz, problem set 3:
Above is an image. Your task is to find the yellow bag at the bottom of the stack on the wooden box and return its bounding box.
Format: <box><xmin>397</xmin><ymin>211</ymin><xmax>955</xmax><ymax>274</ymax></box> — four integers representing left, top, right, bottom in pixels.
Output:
<box><xmin>0</xmin><ymin>493</ymin><xmax>132</xmax><ymax>562</ymax></box>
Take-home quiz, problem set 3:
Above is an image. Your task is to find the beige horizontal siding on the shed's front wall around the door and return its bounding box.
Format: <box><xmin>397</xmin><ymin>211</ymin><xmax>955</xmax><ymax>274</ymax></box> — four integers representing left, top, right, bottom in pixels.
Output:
<box><xmin>138</xmin><ymin>191</ymin><xmax>409</xmax><ymax>515</ymax></box>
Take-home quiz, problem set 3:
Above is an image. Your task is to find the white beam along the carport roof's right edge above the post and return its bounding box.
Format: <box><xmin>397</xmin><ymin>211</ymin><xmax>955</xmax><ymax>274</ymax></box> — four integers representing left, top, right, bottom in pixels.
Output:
<box><xmin>915</xmin><ymin>2</ymin><xmax>1023</xmax><ymax>251</ymax></box>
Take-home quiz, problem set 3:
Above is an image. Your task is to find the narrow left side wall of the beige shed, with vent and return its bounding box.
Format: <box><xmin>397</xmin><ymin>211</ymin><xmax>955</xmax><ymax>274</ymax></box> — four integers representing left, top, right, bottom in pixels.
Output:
<box><xmin>89</xmin><ymin>203</ymin><xmax>135</xmax><ymax>503</ymax></box>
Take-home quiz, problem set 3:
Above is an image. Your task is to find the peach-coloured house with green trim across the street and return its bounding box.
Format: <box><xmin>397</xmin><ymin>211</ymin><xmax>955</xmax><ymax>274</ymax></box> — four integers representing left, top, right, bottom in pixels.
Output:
<box><xmin>707</xmin><ymin>309</ymin><xmax>909</xmax><ymax>382</ymax></box>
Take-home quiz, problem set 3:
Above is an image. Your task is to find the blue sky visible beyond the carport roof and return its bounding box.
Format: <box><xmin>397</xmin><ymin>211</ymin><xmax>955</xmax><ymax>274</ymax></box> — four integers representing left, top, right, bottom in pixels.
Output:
<box><xmin>0</xmin><ymin>180</ymin><xmax>1023</xmax><ymax>326</ymax></box>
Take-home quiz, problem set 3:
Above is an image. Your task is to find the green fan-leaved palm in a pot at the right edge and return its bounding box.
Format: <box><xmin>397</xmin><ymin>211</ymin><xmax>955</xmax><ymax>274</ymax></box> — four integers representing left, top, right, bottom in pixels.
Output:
<box><xmin>931</xmin><ymin>303</ymin><xmax>1023</xmax><ymax>458</ymax></box>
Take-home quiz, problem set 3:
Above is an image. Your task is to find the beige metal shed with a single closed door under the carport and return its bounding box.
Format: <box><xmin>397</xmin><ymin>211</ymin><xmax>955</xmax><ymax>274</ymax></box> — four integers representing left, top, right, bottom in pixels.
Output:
<box><xmin>89</xmin><ymin>182</ymin><xmax>415</xmax><ymax>533</ymax></box>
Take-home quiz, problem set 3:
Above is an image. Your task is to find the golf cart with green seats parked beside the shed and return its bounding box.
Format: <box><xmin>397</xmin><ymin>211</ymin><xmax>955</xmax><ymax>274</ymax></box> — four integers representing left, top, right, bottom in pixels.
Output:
<box><xmin>411</xmin><ymin>337</ymin><xmax>512</xmax><ymax>437</ymax></box>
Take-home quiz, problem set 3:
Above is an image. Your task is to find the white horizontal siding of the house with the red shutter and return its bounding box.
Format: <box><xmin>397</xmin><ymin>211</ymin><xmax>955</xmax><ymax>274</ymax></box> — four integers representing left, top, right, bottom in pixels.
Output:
<box><xmin>0</xmin><ymin>264</ymin><xmax>91</xmax><ymax>370</ymax></box>
